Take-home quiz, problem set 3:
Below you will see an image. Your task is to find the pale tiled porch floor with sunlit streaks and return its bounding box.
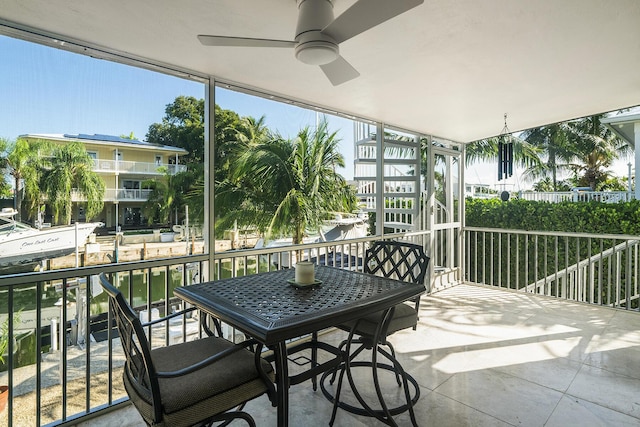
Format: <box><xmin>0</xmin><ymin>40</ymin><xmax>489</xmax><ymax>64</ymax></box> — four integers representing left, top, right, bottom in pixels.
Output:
<box><xmin>81</xmin><ymin>285</ymin><xmax>640</xmax><ymax>427</ymax></box>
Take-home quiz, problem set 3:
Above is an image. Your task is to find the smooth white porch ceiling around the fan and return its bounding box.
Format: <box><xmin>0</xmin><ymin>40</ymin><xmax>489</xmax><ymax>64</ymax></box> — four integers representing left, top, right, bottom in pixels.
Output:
<box><xmin>0</xmin><ymin>0</ymin><xmax>640</xmax><ymax>142</ymax></box>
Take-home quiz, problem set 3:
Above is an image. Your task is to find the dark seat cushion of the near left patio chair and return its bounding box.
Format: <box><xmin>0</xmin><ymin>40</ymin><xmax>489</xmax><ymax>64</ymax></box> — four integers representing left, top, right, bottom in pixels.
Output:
<box><xmin>124</xmin><ymin>337</ymin><xmax>273</xmax><ymax>426</ymax></box>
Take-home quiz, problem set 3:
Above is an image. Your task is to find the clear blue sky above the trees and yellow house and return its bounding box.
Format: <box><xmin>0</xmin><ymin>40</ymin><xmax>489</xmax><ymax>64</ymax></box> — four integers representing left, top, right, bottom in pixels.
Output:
<box><xmin>0</xmin><ymin>36</ymin><xmax>353</xmax><ymax>179</ymax></box>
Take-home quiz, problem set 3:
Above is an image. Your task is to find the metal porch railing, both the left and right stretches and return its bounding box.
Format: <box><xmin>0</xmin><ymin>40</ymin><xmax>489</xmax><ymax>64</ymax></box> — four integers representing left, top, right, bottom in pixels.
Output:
<box><xmin>0</xmin><ymin>227</ymin><xmax>640</xmax><ymax>426</ymax></box>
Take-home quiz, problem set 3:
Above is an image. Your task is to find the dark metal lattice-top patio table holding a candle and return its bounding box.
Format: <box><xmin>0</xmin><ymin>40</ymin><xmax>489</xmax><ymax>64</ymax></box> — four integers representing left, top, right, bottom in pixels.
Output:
<box><xmin>174</xmin><ymin>266</ymin><xmax>425</xmax><ymax>426</ymax></box>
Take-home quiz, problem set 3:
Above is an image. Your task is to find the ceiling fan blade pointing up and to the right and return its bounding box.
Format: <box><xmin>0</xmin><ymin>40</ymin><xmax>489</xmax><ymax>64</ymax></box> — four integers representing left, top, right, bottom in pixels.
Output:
<box><xmin>322</xmin><ymin>0</ymin><xmax>424</xmax><ymax>44</ymax></box>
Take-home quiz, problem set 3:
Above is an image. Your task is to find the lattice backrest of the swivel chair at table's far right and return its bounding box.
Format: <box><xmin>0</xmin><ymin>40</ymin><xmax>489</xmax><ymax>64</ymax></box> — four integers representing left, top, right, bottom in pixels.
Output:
<box><xmin>364</xmin><ymin>240</ymin><xmax>429</xmax><ymax>285</ymax></box>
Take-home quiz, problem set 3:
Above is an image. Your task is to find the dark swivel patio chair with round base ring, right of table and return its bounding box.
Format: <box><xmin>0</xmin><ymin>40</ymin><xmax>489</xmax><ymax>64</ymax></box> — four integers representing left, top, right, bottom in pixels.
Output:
<box><xmin>320</xmin><ymin>241</ymin><xmax>430</xmax><ymax>425</ymax></box>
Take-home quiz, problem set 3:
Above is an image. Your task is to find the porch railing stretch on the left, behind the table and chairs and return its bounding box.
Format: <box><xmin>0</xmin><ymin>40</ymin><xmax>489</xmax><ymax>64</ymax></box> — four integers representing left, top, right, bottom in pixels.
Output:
<box><xmin>0</xmin><ymin>233</ymin><xmax>429</xmax><ymax>427</ymax></box>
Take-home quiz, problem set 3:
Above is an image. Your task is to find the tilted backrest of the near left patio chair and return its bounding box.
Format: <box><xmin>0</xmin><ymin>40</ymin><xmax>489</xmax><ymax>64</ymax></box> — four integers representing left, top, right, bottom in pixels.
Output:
<box><xmin>100</xmin><ymin>273</ymin><xmax>162</xmax><ymax>422</ymax></box>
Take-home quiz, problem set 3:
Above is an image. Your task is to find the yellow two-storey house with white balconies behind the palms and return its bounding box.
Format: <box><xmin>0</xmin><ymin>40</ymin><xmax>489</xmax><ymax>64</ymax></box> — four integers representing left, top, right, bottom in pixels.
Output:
<box><xmin>20</xmin><ymin>134</ymin><xmax>187</xmax><ymax>228</ymax></box>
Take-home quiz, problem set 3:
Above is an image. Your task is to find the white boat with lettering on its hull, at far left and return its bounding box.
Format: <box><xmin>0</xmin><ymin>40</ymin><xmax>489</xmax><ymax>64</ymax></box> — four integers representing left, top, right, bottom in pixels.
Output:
<box><xmin>0</xmin><ymin>208</ymin><xmax>104</xmax><ymax>268</ymax></box>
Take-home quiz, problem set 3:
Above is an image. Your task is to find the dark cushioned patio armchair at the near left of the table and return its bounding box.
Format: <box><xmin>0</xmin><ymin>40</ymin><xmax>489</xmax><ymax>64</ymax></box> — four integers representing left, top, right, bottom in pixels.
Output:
<box><xmin>100</xmin><ymin>273</ymin><xmax>275</xmax><ymax>427</ymax></box>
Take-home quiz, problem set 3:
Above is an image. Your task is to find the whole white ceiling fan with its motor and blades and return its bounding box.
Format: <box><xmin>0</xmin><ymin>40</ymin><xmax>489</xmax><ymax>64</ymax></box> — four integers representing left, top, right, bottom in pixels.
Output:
<box><xmin>198</xmin><ymin>0</ymin><xmax>424</xmax><ymax>86</ymax></box>
